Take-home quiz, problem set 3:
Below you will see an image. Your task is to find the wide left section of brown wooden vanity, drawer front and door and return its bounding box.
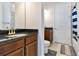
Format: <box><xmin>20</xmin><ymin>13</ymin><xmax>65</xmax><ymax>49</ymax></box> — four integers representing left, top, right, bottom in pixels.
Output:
<box><xmin>0</xmin><ymin>37</ymin><xmax>25</xmax><ymax>56</ymax></box>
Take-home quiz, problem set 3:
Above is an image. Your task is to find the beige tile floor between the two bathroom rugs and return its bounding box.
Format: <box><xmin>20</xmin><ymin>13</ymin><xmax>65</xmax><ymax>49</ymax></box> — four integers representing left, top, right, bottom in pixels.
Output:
<box><xmin>49</xmin><ymin>43</ymin><xmax>67</xmax><ymax>56</ymax></box>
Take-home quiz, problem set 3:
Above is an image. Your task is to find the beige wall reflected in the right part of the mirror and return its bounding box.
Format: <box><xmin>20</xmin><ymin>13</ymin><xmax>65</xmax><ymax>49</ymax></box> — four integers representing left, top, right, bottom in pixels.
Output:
<box><xmin>15</xmin><ymin>2</ymin><xmax>25</xmax><ymax>29</ymax></box>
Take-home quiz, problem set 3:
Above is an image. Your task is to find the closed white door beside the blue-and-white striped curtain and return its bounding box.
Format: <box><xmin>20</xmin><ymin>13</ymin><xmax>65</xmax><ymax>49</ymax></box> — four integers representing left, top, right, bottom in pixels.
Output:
<box><xmin>54</xmin><ymin>3</ymin><xmax>71</xmax><ymax>45</ymax></box>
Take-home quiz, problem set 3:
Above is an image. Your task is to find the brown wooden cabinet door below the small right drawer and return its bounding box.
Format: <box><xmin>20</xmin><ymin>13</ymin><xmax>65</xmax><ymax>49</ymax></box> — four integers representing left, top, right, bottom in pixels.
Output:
<box><xmin>26</xmin><ymin>41</ymin><xmax>37</xmax><ymax>56</ymax></box>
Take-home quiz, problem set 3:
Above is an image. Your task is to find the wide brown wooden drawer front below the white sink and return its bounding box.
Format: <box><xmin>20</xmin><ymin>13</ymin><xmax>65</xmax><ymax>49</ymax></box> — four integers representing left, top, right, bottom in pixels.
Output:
<box><xmin>0</xmin><ymin>38</ymin><xmax>24</xmax><ymax>55</ymax></box>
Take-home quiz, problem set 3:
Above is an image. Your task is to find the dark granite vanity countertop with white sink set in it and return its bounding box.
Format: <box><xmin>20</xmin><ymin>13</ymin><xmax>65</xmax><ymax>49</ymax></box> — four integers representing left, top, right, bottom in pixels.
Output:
<box><xmin>0</xmin><ymin>32</ymin><xmax>37</xmax><ymax>44</ymax></box>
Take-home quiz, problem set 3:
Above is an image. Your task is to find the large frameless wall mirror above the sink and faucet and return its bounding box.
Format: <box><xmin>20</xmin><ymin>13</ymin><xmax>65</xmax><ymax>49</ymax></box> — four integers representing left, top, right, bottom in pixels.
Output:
<box><xmin>0</xmin><ymin>2</ymin><xmax>26</xmax><ymax>30</ymax></box>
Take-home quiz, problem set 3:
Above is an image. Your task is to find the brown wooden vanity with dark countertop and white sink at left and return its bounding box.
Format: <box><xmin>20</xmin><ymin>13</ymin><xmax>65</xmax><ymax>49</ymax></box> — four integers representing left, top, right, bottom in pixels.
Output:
<box><xmin>0</xmin><ymin>33</ymin><xmax>37</xmax><ymax>56</ymax></box>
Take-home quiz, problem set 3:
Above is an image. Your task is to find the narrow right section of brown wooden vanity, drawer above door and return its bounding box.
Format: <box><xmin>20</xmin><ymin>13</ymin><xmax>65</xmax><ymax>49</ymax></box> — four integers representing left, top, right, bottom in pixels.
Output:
<box><xmin>25</xmin><ymin>35</ymin><xmax>37</xmax><ymax>56</ymax></box>
